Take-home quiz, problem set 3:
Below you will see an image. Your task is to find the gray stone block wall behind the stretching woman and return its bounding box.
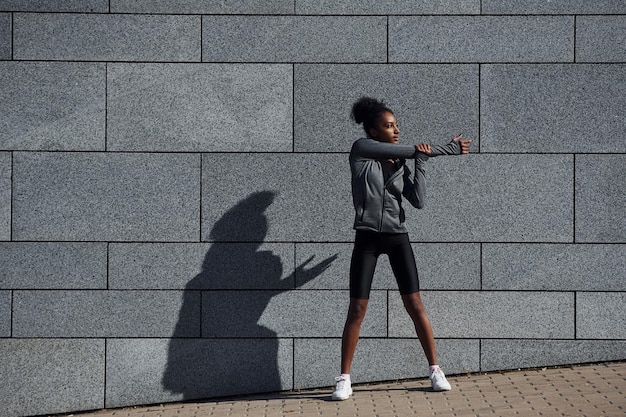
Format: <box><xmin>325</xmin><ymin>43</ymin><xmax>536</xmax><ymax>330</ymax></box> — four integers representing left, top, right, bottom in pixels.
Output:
<box><xmin>0</xmin><ymin>0</ymin><xmax>626</xmax><ymax>416</ymax></box>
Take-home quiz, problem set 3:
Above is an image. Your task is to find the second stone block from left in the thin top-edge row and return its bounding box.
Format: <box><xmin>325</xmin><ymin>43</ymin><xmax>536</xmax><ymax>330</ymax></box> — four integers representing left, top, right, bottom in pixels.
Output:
<box><xmin>110</xmin><ymin>0</ymin><xmax>294</xmax><ymax>15</ymax></box>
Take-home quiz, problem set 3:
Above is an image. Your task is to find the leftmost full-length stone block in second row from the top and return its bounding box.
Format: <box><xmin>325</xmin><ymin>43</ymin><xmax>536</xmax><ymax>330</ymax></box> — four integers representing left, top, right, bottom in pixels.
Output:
<box><xmin>13</xmin><ymin>13</ymin><xmax>201</xmax><ymax>62</ymax></box>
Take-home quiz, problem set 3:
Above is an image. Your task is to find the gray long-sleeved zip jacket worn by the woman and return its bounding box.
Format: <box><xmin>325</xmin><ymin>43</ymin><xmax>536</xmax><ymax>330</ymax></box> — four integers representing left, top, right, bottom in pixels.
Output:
<box><xmin>350</xmin><ymin>138</ymin><xmax>461</xmax><ymax>233</ymax></box>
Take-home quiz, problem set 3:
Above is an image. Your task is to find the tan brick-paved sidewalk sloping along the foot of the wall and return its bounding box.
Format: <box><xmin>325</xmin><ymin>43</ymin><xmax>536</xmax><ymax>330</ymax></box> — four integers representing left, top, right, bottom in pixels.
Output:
<box><xmin>56</xmin><ymin>362</ymin><xmax>626</xmax><ymax>417</ymax></box>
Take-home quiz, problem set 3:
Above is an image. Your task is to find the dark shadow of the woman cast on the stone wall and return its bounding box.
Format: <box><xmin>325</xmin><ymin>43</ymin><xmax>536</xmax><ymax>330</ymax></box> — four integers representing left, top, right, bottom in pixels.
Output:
<box><xmin>162</xmin><ymin>191</ymin><xmax>337</xmax><ymax>400</ymax></box>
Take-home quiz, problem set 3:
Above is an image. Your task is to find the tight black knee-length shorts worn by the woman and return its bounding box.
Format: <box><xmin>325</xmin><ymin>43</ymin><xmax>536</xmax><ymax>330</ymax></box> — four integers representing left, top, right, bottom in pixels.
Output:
<box><xmin>350</xmin><ymin>230</ymin><xmax>420</xmax><ymax>300</ymax></box>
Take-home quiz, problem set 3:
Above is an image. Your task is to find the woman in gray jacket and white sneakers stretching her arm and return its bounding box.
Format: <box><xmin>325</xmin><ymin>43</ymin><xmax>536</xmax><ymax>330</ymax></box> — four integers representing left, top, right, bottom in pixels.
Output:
<box><xmin>332</xmin><ymin>97</ymin><xmax>472</xmax><ymax>400</ymax></box>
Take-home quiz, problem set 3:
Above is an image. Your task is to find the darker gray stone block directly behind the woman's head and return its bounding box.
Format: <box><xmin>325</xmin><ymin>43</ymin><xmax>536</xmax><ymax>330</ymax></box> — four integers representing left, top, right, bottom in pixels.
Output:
<box><xmin>294</xmin><ymin>64</ymin><xmax>479</xmax><ymax>154</ymax></box>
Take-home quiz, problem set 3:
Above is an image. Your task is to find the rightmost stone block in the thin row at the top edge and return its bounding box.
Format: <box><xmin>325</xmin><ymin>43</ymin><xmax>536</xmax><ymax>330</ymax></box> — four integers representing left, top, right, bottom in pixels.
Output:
<box><xmin>481</xmin><ymin>0</ymin><xmax>626</xmax><ymax>15</ymax></box>
